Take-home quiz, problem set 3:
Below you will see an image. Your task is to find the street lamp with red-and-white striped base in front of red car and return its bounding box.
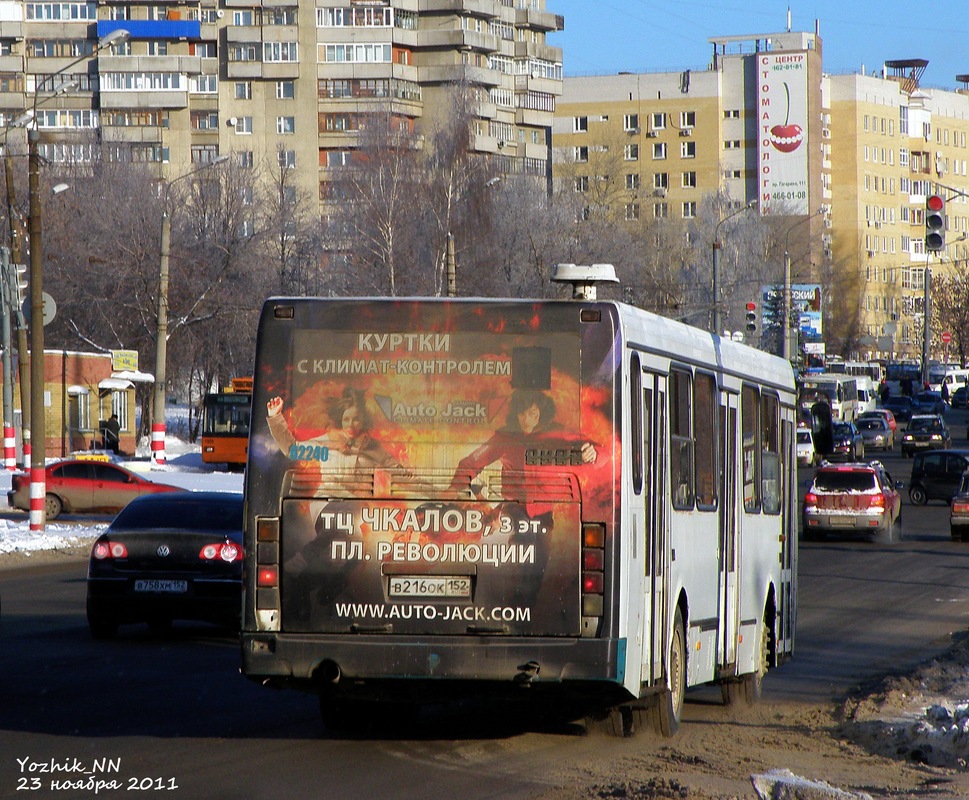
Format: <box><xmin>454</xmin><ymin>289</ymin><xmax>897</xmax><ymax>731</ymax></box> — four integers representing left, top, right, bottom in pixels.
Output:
<box><xmin>27</xmin><ymin>28</ymin><xmax>130</xmax><ymax>531</ymax></box>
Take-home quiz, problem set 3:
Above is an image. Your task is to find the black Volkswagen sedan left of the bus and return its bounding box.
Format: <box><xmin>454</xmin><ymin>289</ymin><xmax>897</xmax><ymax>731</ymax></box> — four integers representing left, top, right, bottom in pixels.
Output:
<box><xmin>87</xmin><ymin>492</ymin><xmax>243</xmax><ymax>639</ymax></box>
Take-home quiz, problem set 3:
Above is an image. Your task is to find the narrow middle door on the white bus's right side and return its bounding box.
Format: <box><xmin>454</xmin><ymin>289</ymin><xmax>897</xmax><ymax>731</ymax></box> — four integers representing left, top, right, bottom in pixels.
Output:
<box><xmin>717</xmin><ymin>394</ymin><xmax>743</xmax><ymax>668</ymax></box>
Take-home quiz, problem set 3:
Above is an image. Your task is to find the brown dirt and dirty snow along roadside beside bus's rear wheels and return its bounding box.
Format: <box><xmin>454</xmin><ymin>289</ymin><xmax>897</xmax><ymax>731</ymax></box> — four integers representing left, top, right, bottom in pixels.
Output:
<box><xmin>541</xmin><ymin>635</ymin><xmax>969</xmax><ymax>800</ymax></box>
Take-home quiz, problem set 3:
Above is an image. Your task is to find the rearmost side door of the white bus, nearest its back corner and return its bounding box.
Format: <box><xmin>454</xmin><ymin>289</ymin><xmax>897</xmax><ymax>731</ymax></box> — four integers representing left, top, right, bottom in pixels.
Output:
<box><xmin>641</xmin><ymin>373</ymin><xmax>670</xmax><ymax>685</ymax></box>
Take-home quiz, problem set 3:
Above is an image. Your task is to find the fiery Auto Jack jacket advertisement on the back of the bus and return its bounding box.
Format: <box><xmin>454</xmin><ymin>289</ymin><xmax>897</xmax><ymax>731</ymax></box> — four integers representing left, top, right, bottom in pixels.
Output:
<box><xmin>250</xmin><ymin>303</ymin><xmax>618</xmax><ymax>636</ymax></box>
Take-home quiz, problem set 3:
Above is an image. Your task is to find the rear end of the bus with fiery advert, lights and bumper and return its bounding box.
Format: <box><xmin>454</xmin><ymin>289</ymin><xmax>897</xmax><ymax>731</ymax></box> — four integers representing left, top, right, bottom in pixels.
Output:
<box><xmin>242</xmin><ymin>299</ymin><xmax>622</xmax><ymax>702</ymax></box>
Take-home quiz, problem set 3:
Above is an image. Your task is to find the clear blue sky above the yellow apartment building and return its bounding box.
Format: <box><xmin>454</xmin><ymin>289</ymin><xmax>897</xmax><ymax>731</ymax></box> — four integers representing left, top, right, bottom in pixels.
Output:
<box><xmin>545</xmin><ymin>0</ymin><xmax>969</xmax><ymax>90</ymax></box>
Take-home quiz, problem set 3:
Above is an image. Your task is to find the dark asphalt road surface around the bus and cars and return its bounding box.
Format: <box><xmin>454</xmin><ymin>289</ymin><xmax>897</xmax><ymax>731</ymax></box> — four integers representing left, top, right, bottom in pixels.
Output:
<box><xmin>0</xmin><ymin>418</ymin><xmax>969</xmax><ymax>800</ymax></box>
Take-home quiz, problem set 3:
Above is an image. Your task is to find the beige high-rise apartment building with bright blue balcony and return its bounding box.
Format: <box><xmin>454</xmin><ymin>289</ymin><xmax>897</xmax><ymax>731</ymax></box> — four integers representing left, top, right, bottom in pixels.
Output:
<box><xmin>0</xmin><ymin>0</ymin><xmax>564</xmax><ymax>213</ymax></box>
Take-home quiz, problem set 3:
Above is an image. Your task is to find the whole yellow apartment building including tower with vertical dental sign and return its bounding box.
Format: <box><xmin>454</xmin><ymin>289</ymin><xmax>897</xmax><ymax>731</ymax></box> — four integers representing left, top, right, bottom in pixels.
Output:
<box><xmin>552</xmin><ymin>30</ymin><xmax>969</xmax><ymax>358</ymax></box>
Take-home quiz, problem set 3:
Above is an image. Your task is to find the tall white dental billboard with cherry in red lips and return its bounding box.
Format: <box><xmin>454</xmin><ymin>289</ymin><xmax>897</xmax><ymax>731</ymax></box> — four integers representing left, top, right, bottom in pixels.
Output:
<box><xmin>757</xmin><ymin>52</ymin><xmax>809</xmax><ymax>214</ymax></box>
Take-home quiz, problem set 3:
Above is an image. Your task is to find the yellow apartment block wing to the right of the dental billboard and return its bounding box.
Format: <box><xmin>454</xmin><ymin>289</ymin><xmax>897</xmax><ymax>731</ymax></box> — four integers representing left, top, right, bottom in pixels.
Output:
<box><xmin>826</xmin><ymin>64</ymin><xmax>969</xmax><ymax>357</ymax></box>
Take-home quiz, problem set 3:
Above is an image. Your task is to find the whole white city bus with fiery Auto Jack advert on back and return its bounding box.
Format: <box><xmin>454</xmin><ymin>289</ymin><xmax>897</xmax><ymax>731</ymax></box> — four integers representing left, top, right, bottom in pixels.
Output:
<box><xmin>241</xmin><ymin>265</ymin><xmax>798</xmax><ymax>736</ymax></box>
